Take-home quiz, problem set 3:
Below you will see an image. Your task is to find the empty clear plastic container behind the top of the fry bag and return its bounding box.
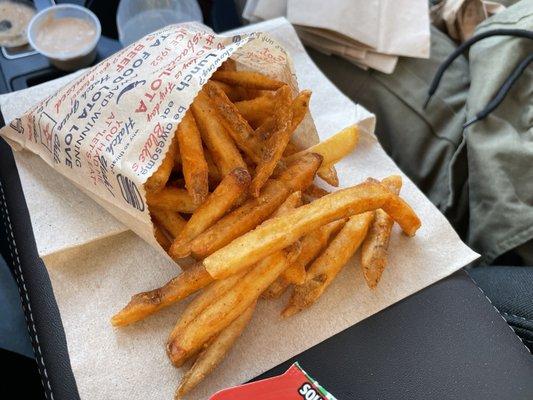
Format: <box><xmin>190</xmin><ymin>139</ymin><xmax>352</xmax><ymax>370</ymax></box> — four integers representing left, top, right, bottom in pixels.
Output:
<box><xmin>117</xmin><ymin>0</ymin><xmax>203</xmax><ymax>47</ymax></box>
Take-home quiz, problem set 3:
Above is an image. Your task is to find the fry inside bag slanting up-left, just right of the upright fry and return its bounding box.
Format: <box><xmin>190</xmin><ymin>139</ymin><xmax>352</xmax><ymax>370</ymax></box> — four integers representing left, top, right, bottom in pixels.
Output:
<box><xmin>192</xmin><ymin>91</ymin><xmax>246</xmax><ymax>176</ymax></box>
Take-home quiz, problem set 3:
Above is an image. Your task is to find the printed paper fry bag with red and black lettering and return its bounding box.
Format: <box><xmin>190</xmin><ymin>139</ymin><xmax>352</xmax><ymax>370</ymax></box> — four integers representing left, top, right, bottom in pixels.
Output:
<box><xmin>0</xmin><ymin>23</ymin><xmax>318</xmax><ymax>260</ymax></box>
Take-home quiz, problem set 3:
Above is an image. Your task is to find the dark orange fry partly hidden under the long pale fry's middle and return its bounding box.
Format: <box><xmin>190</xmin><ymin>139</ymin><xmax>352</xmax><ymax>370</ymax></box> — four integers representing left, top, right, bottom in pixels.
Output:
<box><xmin>263</xmin><ymin>219</ymin><xmax>346</xmax><ymax>299</ymax></box>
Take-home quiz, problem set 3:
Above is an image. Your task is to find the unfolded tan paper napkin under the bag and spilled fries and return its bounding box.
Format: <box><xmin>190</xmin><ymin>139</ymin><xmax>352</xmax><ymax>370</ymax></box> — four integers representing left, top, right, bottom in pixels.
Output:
<box><xmin>0</xmin><ymin>19</ymin><xmax>477</xmax><ymax>400</ymax></box>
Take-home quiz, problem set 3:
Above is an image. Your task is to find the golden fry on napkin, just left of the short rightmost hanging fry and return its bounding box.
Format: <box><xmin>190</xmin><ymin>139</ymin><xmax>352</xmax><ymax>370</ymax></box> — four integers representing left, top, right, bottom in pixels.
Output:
<box><xmin>281</xmin><ymin>212</ymin><xmax>374</xmax><ymax>318</ymax></box>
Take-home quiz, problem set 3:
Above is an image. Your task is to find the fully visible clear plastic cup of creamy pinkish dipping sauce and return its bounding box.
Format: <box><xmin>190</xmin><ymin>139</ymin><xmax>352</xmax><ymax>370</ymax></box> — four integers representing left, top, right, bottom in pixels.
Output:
<box><xmin>28</xmin><ymin>4</ymin><xmax>102</xmax><ymax>71</ymax></box>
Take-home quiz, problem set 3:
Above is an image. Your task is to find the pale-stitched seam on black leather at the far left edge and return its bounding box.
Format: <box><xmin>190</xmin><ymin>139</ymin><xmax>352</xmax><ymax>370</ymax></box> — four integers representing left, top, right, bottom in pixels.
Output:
<box><xmin>0</xmin><ymin>182</ymin><xmax>54</xmax><ymax>400</ymax></box>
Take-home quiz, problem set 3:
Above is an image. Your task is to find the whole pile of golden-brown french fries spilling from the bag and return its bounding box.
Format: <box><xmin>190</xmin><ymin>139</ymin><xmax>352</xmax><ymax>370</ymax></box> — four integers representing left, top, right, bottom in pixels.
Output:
<box><xmin>112</xmin><ymin>60</ymin><xmax>420</xmax><ymax>398</ymax></box>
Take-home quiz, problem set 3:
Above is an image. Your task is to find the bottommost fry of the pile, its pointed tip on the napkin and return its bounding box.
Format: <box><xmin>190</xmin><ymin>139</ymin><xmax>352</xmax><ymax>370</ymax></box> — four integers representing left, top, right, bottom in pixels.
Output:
<box><xmin>175</xmin><ymin>303</ymin><xmax>256</xmax><ymax>400</ymax></box>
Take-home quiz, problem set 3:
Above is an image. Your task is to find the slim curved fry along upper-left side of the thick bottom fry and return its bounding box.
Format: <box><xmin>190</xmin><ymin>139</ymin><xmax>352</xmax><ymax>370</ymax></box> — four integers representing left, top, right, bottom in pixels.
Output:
<box><xmin>167</xmin><ymin>271</ymin><xmax>246</xmax><ymax>346</ymax></box>
